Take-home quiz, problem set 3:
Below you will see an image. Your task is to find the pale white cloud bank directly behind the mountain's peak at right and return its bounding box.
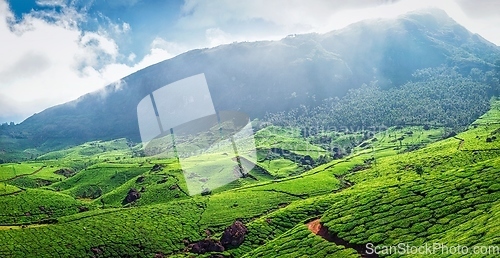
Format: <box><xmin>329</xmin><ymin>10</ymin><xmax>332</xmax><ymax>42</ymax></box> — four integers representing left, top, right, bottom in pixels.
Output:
<box><xmin>179</xmin><ymin>0</ymin><xmax>500</xmax><ymax>45</ymax></box>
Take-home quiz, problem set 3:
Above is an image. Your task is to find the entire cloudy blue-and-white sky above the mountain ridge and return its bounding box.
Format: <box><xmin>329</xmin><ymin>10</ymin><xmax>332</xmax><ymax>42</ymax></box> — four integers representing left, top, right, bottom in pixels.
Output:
<box><xmin>0</xmin><ymin>0</ymin><xmax>500</xmax><ymax>123</ymax></box>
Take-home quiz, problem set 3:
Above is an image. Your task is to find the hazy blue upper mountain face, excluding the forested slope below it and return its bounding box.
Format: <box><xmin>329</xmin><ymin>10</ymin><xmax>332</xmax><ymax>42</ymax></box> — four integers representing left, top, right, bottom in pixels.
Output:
<box><xmin>0</xmin><ymin>9</ymin><xmax>500</xmax><ymax>155</ymax></box>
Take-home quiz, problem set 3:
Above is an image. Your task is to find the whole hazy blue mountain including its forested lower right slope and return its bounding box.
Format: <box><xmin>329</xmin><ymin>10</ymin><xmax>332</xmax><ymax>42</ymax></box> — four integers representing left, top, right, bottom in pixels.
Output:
<box><xmin>0</xmin><ymin>9</ymin><xmax>500</xmax><ymax>161</ymax></box>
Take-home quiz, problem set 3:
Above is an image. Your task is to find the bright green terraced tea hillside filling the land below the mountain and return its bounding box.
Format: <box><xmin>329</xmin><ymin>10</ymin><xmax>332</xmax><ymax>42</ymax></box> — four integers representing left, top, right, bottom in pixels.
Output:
<box><xmin>0</xmin><ymin>100</ymin><xmax>500</xmax><ymax>257</ymax></box>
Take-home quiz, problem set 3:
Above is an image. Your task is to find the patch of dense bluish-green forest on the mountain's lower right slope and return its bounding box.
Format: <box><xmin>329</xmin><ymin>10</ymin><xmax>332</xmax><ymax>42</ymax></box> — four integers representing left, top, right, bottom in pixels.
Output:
<box><xmin>265</xmin><ymin>67</ymin><xmax>499</xmax><ymax>137</ymax></box>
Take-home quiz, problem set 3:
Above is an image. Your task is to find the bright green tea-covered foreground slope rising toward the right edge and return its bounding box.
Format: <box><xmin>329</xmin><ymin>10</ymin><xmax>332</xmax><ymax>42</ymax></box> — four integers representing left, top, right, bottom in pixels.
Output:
<box><xmin>0</xmin><ymin>102</ymin><xmax>500</xmax><ymax>257</ymax></box>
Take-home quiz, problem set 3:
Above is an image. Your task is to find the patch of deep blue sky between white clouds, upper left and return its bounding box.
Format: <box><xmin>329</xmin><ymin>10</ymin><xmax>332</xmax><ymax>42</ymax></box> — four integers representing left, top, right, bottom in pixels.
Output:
<box><xmin>7</xmin><ymin>0</ymin><xmax>184</xmax><ymax>63</ymax></box>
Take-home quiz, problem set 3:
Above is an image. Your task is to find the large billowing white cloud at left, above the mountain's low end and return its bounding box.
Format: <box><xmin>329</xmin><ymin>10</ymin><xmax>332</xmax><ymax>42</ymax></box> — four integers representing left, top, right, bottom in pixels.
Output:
<box><xmin>0</xmin><ymin>0</ymin><xmax>181</xmax><ymax>122</ymax></box>
